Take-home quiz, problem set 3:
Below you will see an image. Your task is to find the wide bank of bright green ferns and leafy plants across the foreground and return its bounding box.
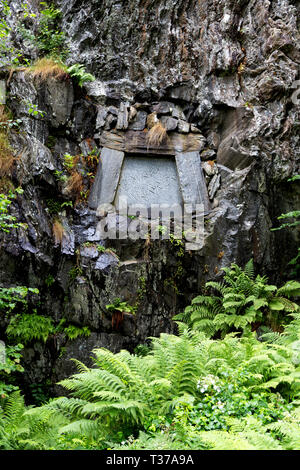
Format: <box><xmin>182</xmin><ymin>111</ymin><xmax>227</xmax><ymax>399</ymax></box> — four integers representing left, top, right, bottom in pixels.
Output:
<box><xmin>0</xmin><ymin>320</ymin><xmax>300</xmax><ymax>450</ymax></box>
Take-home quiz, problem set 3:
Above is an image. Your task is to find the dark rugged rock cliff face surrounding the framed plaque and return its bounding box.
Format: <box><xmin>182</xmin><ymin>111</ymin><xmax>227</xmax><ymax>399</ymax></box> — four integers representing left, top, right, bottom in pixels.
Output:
<box><xmin>0</xmin><ymin>0</ymin><xmax>300</xmax><ymax>394</ymax></box>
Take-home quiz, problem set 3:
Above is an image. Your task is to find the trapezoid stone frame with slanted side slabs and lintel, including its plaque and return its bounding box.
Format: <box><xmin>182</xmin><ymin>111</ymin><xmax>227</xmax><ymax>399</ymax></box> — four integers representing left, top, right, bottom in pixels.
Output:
<box><xmin>89</xmin><ymin>131</ymin><xmax>209</xmax><ymax>211</ymax></box>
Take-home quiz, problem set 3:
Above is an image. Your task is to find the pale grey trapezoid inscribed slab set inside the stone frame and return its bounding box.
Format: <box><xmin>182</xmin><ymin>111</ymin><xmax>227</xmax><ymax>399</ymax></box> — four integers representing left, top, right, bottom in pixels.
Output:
<box><xmin>116</xmin><ymin>155</ymin><xmax>183</xmax><ymax>208</ymax></box>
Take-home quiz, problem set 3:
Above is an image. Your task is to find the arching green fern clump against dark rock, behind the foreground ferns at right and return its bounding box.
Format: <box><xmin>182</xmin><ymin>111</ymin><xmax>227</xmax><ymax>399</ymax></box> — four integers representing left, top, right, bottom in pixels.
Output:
<box><xmin>174</xmin><ymin>260</ymin><xmax>300</xmax><ymax>337</ymax></box>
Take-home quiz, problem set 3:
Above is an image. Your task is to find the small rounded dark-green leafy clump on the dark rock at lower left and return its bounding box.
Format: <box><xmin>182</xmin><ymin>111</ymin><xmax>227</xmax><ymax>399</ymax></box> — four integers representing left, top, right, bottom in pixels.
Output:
<box><xmin>6</xmin><ymin>313</ymin><xmax>55</xmax><ymax>344</ymax></box>
